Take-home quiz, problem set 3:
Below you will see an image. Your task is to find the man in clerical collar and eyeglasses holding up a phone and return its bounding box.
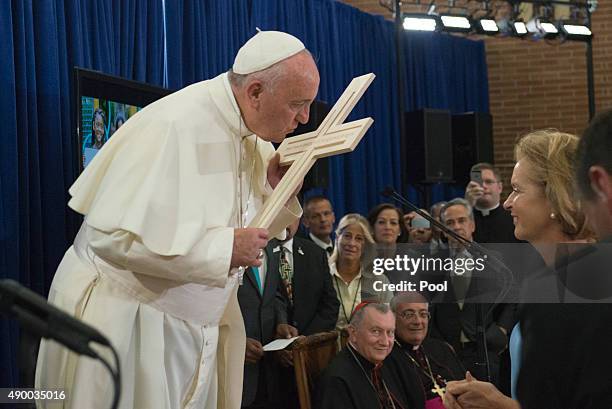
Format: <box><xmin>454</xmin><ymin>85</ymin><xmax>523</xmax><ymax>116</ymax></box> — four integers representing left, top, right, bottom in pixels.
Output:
<box><xmin>465</xmin><ymin>162</ymin><xmax>518</xmax><ymax>243</ymax></box>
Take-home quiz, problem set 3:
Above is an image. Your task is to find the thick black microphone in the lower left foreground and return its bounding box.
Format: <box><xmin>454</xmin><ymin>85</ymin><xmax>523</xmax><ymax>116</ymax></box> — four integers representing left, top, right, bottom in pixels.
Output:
<box><xmin>0</xmin><ymin>279</ymin><xmax>111</xmax><ymax>359</ymax></box>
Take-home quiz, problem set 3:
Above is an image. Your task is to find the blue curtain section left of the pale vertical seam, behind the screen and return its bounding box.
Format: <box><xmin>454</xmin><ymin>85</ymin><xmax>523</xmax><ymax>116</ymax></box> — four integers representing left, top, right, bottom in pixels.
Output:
<box><xmin>0</xmin><ymin>0</ymin><xmax>164</xmax><ymax>387</ymax></box>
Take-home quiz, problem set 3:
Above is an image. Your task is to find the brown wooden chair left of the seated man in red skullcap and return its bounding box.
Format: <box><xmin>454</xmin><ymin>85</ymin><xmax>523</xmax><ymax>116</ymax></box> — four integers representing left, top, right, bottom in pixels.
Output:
<box><xmin>291</xmin><ymin>331</ymin><xmax>338</xmax><ymax>409</ymax></box>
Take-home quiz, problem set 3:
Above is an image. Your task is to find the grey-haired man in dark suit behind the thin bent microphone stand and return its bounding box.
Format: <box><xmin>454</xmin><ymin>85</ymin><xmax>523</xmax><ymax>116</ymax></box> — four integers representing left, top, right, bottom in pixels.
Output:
<box><xmin>431</xmin><ymin>198</ymin><xmax>516</xmax><ymax>382</ymax></box>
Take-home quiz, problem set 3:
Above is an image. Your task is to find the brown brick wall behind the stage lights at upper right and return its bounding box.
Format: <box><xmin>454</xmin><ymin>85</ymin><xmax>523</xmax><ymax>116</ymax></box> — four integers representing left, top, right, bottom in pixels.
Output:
<box><xmin>344</xmin><ymin>0</ymin><xmax>612</xmax><ymax>193</ymax></box>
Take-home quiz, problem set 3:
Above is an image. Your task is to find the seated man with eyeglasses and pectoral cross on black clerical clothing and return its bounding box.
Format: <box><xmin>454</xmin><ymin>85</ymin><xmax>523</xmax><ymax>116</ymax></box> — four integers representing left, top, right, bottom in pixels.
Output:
<box><xmin>385</xmin><ymin>292</ymin><xmax>465</xmax><ymax>408</ymax></box>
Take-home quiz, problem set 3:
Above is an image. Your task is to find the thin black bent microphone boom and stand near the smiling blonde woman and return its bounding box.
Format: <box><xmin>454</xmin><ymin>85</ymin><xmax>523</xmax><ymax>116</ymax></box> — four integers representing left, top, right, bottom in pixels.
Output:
<box><xmin>381</xmin><ymin>186</ymin><xmax>514</xmax><ymax>382</ymax></box>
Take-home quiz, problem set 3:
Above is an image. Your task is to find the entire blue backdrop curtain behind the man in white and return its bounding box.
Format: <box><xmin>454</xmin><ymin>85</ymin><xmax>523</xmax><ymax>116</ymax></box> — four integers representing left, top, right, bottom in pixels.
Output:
<box><xmin>0</xmin><ymin>0</ymin><xmax>488</xmax><ymax>386</ymax></box>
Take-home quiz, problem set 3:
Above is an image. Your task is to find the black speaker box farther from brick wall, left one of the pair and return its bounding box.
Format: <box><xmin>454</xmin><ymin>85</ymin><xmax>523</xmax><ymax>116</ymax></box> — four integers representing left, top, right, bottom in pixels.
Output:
<box><xmin>403</xmin><ymin>109</ymin><xmax>453</xmax><ymax>183</ymax></box>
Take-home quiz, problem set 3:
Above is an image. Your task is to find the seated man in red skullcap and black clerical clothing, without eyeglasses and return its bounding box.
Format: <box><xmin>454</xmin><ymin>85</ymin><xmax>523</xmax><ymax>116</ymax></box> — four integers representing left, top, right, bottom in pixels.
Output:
<box><xmin>314</xmin><ymin>303</ymin><xmax>424</xmax><ymax>409</ymax></box>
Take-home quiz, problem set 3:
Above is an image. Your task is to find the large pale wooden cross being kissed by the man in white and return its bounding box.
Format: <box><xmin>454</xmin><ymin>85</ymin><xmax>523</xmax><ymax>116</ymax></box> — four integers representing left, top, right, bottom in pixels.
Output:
<box><xmin>249</xmin><ymin>73</ymin><xmax>375</xmax><ymax>229</ymax></box>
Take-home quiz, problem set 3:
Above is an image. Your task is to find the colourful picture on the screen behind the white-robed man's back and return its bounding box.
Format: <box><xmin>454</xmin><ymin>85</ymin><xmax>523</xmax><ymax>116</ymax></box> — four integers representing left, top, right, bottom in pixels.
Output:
<box><xmin>81</xmin><ymin>96</ymin><xmax>141</xmax><ymax>169</ymax></box>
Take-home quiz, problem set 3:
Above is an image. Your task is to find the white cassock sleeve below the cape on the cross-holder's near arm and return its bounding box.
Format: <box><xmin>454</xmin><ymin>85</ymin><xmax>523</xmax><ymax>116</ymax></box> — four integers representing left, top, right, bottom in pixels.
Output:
<box><xmin>87</xmin><ymin>226</ymin><xmax>234</xmax><ymax>288</ymax></box>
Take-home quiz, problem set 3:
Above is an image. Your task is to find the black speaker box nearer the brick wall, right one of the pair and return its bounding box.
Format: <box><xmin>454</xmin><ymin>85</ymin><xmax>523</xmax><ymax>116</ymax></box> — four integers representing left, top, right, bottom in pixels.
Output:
<box><xmin>452</xmin><ymin>112</ymin><xmax>493</xmax><ymax>185</ymax></box>
